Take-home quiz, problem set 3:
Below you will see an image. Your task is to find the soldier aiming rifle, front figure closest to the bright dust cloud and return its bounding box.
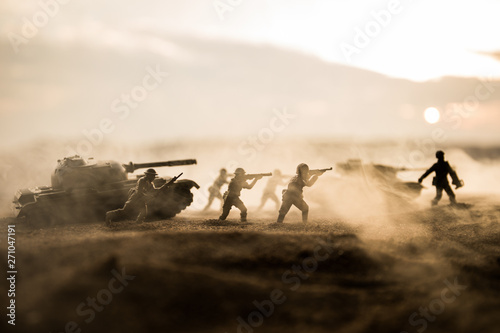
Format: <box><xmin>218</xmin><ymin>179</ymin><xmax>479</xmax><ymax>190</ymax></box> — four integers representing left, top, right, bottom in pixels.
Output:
<box><xmin>276</xmin><ymin>163</ymin><xmax>332</xmax><ymax>223</ymax></box>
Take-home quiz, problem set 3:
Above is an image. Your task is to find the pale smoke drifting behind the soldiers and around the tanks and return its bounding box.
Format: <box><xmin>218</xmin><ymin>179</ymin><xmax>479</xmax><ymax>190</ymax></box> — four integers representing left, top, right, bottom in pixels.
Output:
<box><xmin>0</xmin><ymin>138</ymin><xmax>500</xmax><ymax>225</ymax></box>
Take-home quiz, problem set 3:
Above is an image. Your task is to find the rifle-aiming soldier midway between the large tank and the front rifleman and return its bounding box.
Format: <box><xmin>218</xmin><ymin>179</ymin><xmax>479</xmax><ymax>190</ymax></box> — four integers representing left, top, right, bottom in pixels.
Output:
<box><xmin>219</xmin><ymin>168</ymin><xmax>271</xmax><ymax>222</ymax></box>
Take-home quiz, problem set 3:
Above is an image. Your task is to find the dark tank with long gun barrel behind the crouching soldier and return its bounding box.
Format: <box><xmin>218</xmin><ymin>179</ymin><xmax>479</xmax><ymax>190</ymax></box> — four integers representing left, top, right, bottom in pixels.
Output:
<box><xmin>13</xmin><ymin>155</ymin><xmax>199</xmax><ymax>224</ymax></box>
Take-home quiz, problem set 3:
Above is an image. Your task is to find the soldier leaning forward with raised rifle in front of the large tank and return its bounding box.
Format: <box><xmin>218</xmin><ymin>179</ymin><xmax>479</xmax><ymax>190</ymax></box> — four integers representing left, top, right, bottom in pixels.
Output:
<box><xmin>106</xmin><ymin>169</ymin><xmax>182</xmax><ymax>227</ymax></box>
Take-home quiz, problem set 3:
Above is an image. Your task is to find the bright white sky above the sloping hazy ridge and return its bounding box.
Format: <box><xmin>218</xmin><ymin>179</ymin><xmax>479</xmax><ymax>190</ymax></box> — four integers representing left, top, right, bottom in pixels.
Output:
<box><xmin>0</xmin><ymin>0</ymin><xmax>500</xmax><ymax>80</ymax></box>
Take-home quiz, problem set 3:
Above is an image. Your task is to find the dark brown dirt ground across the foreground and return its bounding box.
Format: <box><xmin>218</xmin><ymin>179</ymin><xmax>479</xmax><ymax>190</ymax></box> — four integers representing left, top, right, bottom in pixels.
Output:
<box><xmin>0</xmin><ymin>196</ymin><xmax>500</xmax><ymax>333</ymax></box>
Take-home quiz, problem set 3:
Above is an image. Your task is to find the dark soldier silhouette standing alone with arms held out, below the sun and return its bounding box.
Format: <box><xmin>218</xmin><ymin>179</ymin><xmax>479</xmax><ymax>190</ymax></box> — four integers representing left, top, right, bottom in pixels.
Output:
<box><xmin>418</xmin><ymin>150</ymin><xmax>463</xmax><ymax>206</ymax></box>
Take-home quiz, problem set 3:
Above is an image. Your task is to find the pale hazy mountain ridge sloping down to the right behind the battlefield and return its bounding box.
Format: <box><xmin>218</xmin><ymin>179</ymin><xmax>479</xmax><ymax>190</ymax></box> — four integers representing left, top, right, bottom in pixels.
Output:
<box><xmin>0</xmin><ymin>31</ymin><xmax>500</xmax><ymax>140</ymax></box>
